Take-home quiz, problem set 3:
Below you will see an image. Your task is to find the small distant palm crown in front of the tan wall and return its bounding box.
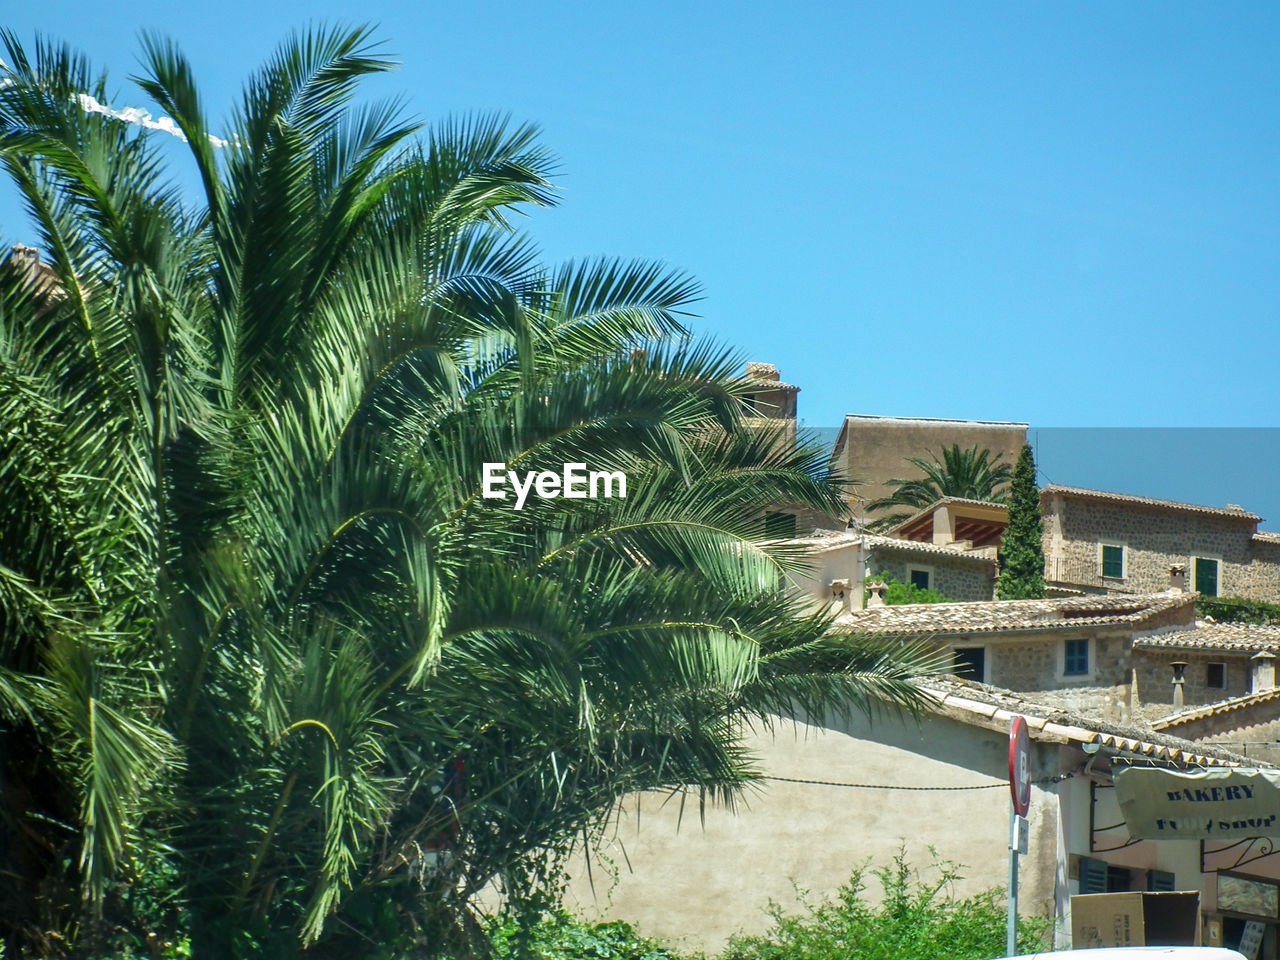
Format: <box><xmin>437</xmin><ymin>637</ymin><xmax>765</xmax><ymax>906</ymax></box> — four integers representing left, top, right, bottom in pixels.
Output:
<box><xmin>867</xmin><ymin>443</ymin><xmax>1012</xmax><ymax>530</ymax></box>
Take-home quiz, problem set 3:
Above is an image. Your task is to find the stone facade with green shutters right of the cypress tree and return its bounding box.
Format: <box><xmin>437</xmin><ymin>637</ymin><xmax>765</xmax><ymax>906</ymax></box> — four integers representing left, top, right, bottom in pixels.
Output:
<box><xmin>1041</xmin><ymin>486</ymin><xmax>1280</xmax><ymax>600</ymax></box>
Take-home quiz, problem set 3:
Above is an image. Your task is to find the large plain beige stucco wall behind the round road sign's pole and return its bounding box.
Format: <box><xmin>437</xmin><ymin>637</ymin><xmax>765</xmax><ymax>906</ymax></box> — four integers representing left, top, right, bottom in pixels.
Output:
<box><xmin>570</xmin><ymin>717</ymin><xmax>1057</xmax><ymax>950</ymax></box>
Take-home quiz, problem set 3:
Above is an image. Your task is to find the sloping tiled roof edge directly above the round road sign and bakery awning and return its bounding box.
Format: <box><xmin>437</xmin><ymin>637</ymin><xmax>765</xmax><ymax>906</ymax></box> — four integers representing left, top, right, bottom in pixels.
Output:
<box><xmin>918</xmin><ymin>677</ymin><xmax>1258</xmax><ymax>767</ymax></box>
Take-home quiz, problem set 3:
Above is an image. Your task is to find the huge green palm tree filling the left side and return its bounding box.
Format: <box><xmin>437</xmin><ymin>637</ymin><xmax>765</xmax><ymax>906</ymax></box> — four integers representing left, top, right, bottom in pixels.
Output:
<box><xmin>0</xmin><ymin>29</ymin><xmax>942</xmax><ymax>956</ymax></box>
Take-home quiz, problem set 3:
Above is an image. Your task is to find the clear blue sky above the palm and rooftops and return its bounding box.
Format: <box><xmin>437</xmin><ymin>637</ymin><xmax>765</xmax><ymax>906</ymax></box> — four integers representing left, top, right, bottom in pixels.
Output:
<box><xmin>0</xmin><ymin>0</ymin><xmax>1280</xmax><ymax>519</ymax></box>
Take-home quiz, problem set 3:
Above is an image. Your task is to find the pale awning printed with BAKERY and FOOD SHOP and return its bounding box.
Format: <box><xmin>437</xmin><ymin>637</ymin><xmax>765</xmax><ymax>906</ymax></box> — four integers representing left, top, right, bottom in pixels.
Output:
<box><xmin>1112</xmin><ymin>767</ymin><xmax>1280</xmax><ymax>840</ymax></box>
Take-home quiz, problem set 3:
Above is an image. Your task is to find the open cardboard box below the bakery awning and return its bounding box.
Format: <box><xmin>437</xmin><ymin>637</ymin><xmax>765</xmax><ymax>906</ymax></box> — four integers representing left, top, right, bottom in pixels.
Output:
<box><xmin>1071</xmin><ymin>891</ymin><xmax>1201</xmax><ymax>950</ymax></box>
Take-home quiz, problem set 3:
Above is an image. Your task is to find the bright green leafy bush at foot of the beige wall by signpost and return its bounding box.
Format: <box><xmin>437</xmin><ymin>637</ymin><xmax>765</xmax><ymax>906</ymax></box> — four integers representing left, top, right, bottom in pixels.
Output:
<box><xmin>723</xmin><ymin>852</ymin><xmax>1050</xmax><ymax>960</ymax></box>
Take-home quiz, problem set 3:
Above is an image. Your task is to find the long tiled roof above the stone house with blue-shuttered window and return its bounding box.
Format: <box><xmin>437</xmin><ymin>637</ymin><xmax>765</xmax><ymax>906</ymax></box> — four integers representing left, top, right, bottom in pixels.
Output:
<box><xmin>835</xmin><ymin>594</ymin><xmax>1197</xmax><ymax>635</ymax></box>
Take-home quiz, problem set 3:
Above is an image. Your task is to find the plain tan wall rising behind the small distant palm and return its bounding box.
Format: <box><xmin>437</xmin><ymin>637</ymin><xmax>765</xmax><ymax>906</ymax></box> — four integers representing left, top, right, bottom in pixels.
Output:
<box><xmin>832</xmin><ymin>416</ymin><xmax>1027</xmax><ymax>516</ymax></box>
